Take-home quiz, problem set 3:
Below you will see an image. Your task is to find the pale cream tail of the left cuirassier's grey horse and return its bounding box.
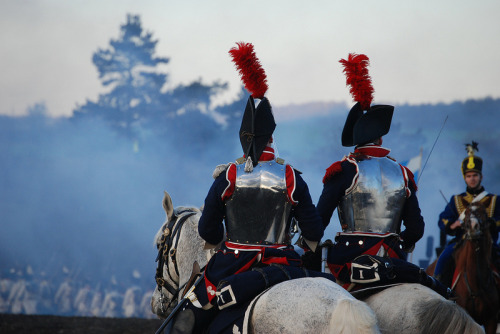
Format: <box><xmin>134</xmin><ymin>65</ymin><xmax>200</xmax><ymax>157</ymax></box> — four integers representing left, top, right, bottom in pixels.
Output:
<box><xmin>329</xmin><ymin>299</ymin><xmax>380</xmax><ymax>334</ymax></box>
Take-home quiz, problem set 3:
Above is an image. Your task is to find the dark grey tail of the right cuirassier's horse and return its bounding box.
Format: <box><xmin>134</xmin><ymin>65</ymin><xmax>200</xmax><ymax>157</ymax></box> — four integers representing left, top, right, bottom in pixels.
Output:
<box><xmin>417</xmin><ymin>298</ymin><xmax>484</xmax><ymax>334</ymax></box>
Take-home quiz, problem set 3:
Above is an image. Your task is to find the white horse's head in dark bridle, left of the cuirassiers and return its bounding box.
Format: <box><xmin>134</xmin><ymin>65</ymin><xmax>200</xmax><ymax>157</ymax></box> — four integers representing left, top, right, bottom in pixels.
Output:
<box><xmin>151</xmin><ymin>192</ymin><xmax>209</xmax><ymax>318</ymax></box>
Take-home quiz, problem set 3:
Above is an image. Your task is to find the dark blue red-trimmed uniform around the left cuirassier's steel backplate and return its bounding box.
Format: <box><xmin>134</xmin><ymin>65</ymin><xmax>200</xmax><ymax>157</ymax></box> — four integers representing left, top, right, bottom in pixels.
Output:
<box><xmin>198</xmin><ymin>148</ymin><xmax>323</xmax><ymax>302</ymax></box>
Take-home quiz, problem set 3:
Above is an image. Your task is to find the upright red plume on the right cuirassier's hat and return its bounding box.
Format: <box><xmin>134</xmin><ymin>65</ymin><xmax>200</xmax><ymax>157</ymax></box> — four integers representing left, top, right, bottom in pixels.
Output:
<box><xmin>339</xmin><ymin>53</ymin><xmax>373</xmax><ymax>110</ymax></box>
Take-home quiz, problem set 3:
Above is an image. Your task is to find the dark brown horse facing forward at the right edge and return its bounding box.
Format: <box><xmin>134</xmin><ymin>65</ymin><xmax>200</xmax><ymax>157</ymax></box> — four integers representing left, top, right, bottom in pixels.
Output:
<box><xmin>427</xmin><ymin>202</ymin><xmax>499</xmax><ymax>334</ymax></box>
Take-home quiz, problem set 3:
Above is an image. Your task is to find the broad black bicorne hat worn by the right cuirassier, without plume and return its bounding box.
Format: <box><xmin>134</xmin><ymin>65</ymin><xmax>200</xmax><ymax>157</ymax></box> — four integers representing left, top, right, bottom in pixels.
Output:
<box><xmin>342</xmin><ymin>102</ymin><xmax>394</xmax><ymax>146</ymax></box>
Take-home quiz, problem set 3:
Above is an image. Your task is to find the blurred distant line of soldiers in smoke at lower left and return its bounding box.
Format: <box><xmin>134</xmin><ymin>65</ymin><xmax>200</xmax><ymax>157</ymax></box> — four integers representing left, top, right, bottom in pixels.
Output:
<box><xmin>0</xmin><ymin>267</ymin><xmax>155</xmax><ymax>318</ymax></box>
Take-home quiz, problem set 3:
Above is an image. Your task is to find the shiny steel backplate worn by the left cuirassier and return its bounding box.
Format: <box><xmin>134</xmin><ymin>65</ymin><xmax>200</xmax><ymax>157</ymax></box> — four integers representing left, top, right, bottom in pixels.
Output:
<box><xmin>225</xmin><ymin>161</ymin><xmax>292</xmax><ymax>245</ymax></box>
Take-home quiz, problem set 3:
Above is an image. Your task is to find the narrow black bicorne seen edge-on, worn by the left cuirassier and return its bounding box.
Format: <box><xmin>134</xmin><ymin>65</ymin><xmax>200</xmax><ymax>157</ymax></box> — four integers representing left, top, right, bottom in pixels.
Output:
<box><xmin>240</xmin><ymin>96</ymin><xmax>276</xmax><ymax>167</ymax></box>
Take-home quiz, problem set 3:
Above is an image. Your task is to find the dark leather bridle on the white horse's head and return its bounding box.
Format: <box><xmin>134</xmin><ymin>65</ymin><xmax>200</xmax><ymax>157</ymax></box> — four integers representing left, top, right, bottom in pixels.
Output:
<box><xmin>155</xmin><ymin>209</ymin><xmax>197</xmax><ymax>313</ymax></box>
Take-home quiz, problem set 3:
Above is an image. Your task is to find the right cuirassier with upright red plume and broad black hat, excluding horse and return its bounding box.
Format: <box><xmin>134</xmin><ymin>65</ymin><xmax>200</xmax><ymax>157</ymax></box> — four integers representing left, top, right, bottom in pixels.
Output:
<box><xmin>312</xmin><ymin>54</ymin><xmax>449</xmax><ymax>297</ymax></box>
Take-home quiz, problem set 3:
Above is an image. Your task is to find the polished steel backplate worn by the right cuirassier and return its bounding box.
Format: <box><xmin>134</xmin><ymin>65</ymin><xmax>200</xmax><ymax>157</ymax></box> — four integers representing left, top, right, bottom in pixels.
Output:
<box><xmin>338</xmin><ymin>158</ymin><xmax>406</xmax><ymax>233</ymax></box>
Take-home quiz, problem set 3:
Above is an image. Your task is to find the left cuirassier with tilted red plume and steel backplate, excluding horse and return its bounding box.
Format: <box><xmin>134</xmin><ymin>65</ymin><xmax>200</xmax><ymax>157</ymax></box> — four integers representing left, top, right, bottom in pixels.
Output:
<box><xmin>166</xmin><ymin>43</ymin><xmax>342</xmax><ymax>334</ymax></box>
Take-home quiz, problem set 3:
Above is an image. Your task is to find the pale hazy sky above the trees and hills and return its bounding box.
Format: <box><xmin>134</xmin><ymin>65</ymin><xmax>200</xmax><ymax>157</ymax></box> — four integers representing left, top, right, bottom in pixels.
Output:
<box><xmin>0</xmin><ymin>0</ymin><xmax>500</xmax><ymax>115</ymax></box>
